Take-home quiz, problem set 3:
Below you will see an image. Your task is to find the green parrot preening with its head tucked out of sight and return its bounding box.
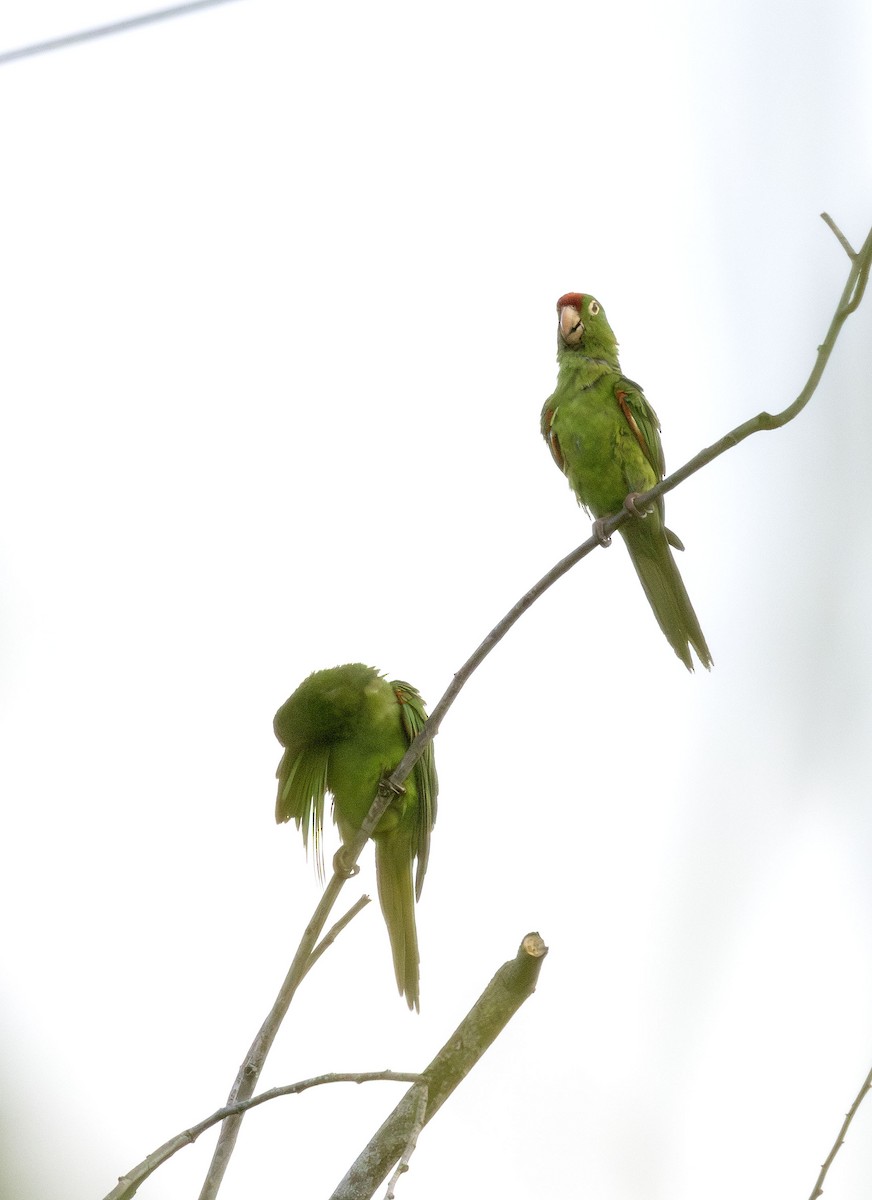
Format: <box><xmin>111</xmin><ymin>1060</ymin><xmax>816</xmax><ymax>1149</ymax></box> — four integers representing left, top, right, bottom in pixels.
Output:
<box><xmin>273</xmin><ymin>662</ymin><xmax>439</xmax><ymax>1010</ymax></box>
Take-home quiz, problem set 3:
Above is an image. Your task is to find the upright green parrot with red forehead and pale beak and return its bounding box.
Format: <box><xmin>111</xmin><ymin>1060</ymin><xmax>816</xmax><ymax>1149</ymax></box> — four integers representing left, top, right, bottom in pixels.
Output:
<box><xmin>541</xmin><ymin>292</ymin><xmax>711</xmax><ymax>671</ymax></box>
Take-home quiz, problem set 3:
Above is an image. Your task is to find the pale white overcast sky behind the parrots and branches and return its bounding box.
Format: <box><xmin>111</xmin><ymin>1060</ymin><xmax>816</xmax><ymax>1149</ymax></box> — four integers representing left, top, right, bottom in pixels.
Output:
<box><xmin>0</xmin><ymin>0</ymin><xmax>872</xmax><ymax>1200</ymax></box>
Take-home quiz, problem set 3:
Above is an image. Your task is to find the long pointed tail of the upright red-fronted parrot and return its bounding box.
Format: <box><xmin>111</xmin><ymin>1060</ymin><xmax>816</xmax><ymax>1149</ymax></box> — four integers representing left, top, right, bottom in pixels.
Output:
<box><xmin>621</xmin><ymin>523</ymin><xmax>711</xmax><ymax>671</ymax></box>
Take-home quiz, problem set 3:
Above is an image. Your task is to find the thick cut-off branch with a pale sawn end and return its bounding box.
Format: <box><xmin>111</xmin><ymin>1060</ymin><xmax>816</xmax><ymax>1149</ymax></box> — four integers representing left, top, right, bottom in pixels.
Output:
<box><xmin>331</xmin><ymin>934</ymin><xmax>548</xmax><ymax>1200</ymax></box>
